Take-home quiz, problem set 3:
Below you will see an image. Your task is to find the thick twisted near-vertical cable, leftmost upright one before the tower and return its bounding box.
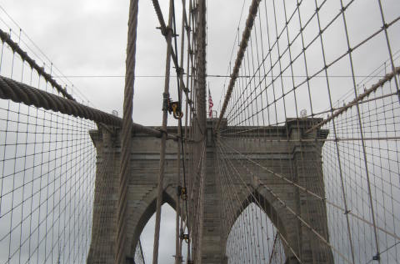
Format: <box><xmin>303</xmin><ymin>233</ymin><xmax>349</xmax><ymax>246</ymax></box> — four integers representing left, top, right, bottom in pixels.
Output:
<box><xmin>115</xmin><ymin>0</ymin><xmax>139</xmax><ymax>264</ymax></box>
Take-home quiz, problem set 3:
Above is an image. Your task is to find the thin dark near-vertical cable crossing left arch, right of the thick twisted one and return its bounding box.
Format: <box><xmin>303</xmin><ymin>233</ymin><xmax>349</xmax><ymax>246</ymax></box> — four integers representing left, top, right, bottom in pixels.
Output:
<box><xmin>153</xmin><ymin>0</ymin><xmax>173</xmax><ymax>264</ymax></box>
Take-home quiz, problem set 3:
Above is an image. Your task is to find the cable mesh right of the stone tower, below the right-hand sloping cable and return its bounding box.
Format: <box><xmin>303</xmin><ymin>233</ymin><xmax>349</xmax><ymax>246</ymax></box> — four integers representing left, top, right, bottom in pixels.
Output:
<box><xmin>323</xmin><ymin>75</ymin><xmax>400</xmax><ymax>263</ymax></box>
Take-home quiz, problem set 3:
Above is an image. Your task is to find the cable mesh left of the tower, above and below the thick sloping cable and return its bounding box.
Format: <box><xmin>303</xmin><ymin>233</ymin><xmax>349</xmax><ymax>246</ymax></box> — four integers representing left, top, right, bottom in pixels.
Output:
<box><xmin>0</xmin><ymin>9</ymin><xmax>96</xmax><ymax>263</ymax></box>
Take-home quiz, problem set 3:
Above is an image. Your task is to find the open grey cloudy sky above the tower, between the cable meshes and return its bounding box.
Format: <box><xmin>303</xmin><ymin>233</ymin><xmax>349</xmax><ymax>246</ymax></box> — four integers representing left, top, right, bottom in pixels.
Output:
<box><xmin>0</xmin><ymin>0</ymin><xmax>249</xmax><ymax>125</ymax></box>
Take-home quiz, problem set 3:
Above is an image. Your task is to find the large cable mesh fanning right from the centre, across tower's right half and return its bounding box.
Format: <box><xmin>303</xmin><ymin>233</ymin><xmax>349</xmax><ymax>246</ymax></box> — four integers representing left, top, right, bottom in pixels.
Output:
<box><xmin>218</xmin><ymin>0</ymin><xmax>400</xmax><ymax>263</ymax></box>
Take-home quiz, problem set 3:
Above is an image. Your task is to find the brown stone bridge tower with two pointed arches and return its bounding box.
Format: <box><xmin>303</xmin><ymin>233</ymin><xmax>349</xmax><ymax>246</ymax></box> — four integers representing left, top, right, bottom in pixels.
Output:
<box><xmin>88</xmin><ymin>119</ymin><xmax>333</xmax><ymax>264</ymax></box>
